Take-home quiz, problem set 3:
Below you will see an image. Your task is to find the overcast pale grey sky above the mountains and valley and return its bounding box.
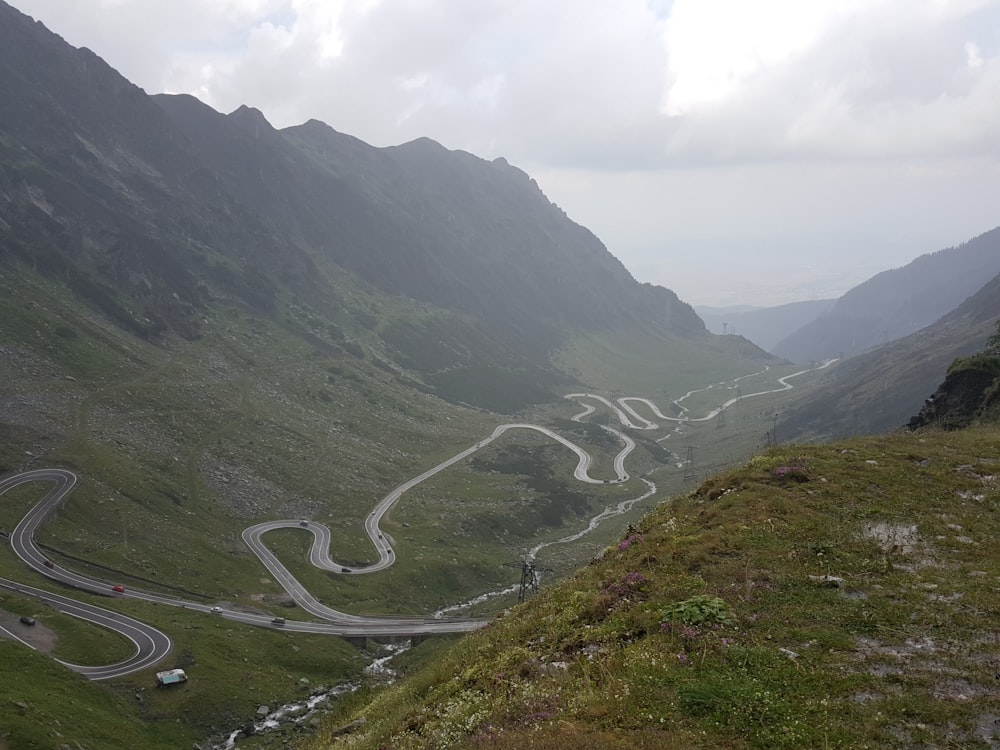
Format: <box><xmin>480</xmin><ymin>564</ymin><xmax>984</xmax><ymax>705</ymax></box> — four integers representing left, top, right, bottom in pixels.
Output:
<box><xmin>12</xmin><ymin>0</ymin><xmax>1000</xmax><ymax>305</ymax></box>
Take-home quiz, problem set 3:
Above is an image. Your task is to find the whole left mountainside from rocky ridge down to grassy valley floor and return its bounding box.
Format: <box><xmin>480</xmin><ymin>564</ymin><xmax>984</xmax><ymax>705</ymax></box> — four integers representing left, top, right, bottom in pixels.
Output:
<box><xmin>0</xmin><ymin>0</ymin><xmax>792</xmax><ymax>750</ymax></box>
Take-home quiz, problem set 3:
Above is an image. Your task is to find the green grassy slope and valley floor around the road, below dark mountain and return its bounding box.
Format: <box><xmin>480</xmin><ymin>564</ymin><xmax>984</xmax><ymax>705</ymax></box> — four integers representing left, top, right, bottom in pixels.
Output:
<box><xmin>0</xmin><ymin>269</ymin><xmax>816</xmax><ymax>747</ymax></box>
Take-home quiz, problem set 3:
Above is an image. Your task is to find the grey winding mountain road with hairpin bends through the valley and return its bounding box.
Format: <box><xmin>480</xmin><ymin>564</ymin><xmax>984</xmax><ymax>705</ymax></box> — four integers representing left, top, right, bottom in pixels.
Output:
<box><xmin>0</xmin><ymin>360</ymin><xmax>834</xmax><ymax>680</ymax></box>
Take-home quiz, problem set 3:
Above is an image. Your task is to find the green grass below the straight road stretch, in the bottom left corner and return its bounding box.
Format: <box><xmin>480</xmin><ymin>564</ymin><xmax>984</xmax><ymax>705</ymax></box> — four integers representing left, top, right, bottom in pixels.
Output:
<box><xmin>0</xmin><ymin>580</ymin><xmax>366</xmax><ymax>748</ymax></box>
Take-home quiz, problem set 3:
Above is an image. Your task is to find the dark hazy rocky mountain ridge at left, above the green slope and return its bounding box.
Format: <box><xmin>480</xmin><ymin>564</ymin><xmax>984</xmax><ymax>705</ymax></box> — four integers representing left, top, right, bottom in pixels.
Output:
<box><xmin>0</xmin><ymin>2</ymin><xmax>742</xmax><ymax>418</ymax></box>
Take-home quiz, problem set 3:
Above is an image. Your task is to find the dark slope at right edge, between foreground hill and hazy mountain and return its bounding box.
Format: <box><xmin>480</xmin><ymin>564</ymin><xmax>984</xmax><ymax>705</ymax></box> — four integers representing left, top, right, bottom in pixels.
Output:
<box><xmin>778</xmin><ymin>275</ymin><xmax>1000</xmax><ymax>441</ymax></box>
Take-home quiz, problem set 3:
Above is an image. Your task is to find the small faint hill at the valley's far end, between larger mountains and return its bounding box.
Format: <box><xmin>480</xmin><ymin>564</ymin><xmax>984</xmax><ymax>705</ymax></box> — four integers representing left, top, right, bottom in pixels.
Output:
<box><xmin>694</xmin><ymin>299</ymin><xmax>836</xmax><ymax>351</ymax></box>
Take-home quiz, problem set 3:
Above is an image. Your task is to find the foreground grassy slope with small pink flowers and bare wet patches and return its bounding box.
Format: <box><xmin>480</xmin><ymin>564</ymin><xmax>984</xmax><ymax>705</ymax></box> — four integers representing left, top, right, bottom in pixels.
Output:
<box><xmin>303</xmin><ymin>427</ymin><xmax>1000</xmax><ymax>750</ymax></box>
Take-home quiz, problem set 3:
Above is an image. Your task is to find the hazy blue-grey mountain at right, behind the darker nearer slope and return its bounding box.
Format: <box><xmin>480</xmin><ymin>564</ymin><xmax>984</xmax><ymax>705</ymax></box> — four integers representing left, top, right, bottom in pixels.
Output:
<box><xmin>771</xmin><ymin>228</ymin><xmax>1000</xmax><ymax>362</ymax></box>
